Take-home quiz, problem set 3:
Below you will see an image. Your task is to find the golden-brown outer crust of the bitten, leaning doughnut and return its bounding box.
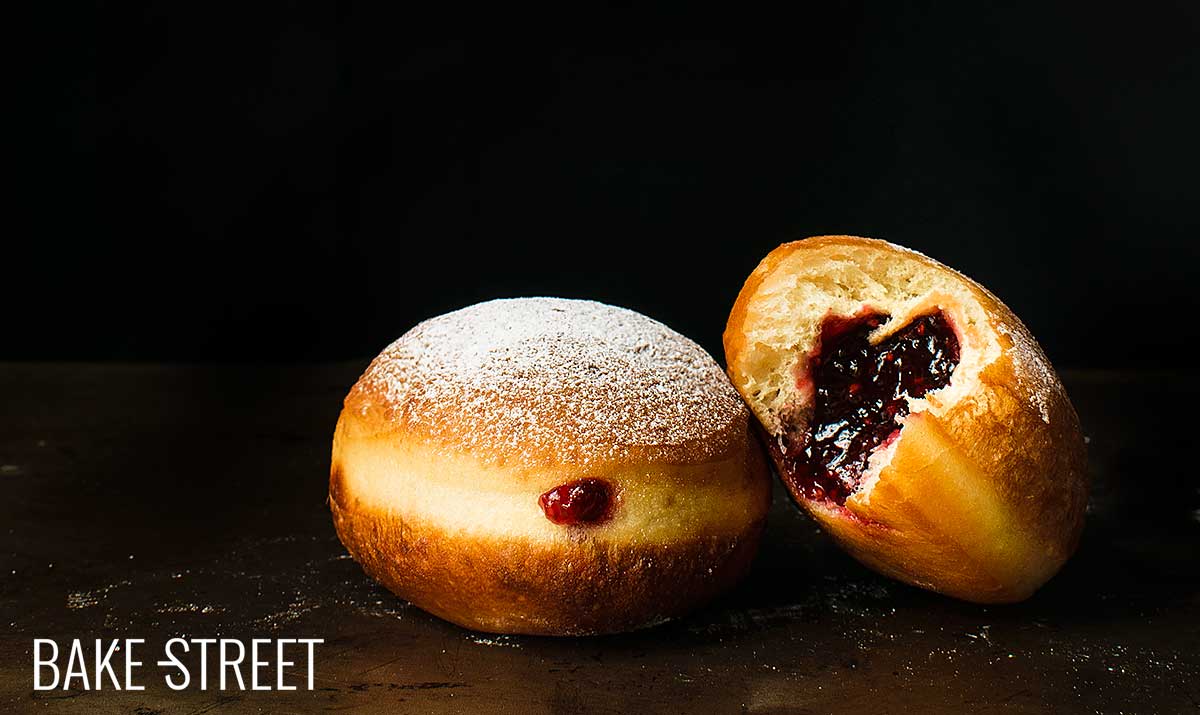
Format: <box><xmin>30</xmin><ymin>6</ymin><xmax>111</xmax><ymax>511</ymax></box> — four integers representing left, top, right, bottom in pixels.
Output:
<box><xmin>725</xmin><ymin>236</ymin><xmax>1087</xmax><ymax>602</ymax></box>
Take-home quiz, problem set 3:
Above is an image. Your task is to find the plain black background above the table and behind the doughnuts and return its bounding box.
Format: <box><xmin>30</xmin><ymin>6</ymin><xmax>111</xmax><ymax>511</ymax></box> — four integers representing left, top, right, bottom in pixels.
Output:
<box><xmin>16</xmin><ymin>2</ymin><xmax>1200</xmax><ymax>367</ymax></box>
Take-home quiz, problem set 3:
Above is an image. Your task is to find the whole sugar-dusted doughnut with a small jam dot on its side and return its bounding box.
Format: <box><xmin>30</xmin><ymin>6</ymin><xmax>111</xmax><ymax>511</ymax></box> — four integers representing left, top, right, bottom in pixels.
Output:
<box><xmin>330</xmin><ymin>299</ymin><xmax>770</xmax><ymax>635</ymax></box>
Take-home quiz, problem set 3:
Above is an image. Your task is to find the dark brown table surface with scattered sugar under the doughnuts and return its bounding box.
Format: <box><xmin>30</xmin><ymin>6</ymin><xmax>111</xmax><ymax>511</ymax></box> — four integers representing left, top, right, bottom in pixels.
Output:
<box><xmin>0</xmin><ymin>362</ymin><xmax>1200</xmax><ymax>715</ymax></box>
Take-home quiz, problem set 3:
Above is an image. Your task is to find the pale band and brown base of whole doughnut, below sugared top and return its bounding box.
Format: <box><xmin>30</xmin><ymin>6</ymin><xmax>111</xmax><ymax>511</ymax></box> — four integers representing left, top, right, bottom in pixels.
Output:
<box><xmin>330</xmin><ymin>413</ymin><xmax>770</xmax><ymax>635</ymax></box>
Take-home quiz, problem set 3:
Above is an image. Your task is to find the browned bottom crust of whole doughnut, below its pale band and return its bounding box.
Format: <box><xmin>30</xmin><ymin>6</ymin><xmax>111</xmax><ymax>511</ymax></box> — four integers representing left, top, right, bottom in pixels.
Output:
<box><xmin>330</xmin><ymin>470</ymin><xmax>763</xmax><ymax>636</ymax></box>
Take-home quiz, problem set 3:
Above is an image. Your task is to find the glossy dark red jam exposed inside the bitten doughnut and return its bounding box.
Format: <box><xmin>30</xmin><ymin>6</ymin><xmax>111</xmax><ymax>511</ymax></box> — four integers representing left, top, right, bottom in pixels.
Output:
<box><xmin>772</xmin><ymin>312</ymin><xmax>959</xmax><ymax>504</ymax></box>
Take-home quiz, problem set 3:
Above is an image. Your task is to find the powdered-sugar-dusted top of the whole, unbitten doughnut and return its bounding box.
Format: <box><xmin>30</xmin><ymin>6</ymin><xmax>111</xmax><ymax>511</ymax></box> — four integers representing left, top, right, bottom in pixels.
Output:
<box><xmin>347</xmin><ymin>298</ymin><xmax>749</xmax><ymax>464</ymax></box>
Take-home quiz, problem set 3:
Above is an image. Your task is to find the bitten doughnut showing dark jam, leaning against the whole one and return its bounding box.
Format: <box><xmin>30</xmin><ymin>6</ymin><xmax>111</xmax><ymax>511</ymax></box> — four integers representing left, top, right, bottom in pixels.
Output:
<box><xmin>725</xmin><ymin>236</ymin><xmax>1087</xmax><ymax>603</ymax></box>
